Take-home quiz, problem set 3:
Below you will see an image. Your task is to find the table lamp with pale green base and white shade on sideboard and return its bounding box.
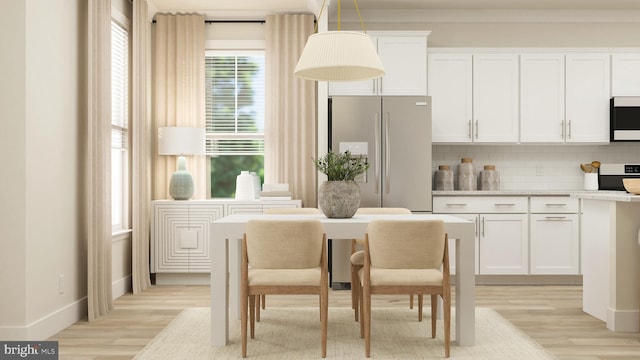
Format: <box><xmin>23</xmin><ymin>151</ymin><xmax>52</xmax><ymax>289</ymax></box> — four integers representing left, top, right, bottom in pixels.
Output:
<box><xmin>158</xmin><ymin>127</ymin><xmax>206</xmax><ymax>200</ymax></box>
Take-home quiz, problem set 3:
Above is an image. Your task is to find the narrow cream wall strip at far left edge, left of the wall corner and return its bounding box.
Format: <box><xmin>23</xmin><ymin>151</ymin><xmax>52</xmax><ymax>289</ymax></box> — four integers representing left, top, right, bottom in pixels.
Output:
<box><xmin>0</xmin><ymin>0</ymin><xmax>26</xmax><ymax>332</ymax></box>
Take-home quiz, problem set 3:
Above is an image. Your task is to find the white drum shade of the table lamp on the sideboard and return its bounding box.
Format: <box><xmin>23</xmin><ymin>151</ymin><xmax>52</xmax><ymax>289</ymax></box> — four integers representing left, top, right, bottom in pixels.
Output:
<box><xmin>158</xmin><ymin>127</ymin><xmax>206</xmax><ymax>155</ymax></box>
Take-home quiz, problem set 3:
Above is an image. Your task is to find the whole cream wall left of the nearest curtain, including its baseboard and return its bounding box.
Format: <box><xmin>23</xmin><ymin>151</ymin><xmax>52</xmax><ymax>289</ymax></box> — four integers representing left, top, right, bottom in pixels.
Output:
<box><xmin>0</xmin><ymin>0</ymin><xmax>87</xmax><ymax>340</ymax></box>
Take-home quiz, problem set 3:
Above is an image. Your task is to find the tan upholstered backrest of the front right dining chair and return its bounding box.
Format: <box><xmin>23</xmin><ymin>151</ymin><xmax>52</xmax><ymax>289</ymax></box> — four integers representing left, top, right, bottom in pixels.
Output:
<box><xmin>367</xmin><ymin>220</ymin><xmax>446</xmax><ymax>269</ymax></box>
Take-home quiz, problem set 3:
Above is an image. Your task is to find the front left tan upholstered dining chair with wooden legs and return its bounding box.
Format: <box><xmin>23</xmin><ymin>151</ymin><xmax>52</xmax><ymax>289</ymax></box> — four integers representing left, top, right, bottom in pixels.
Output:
<box><xmin>241</xmin><ymin>220</ymin><xmax>329</xmax><ymax>357</ymax></box>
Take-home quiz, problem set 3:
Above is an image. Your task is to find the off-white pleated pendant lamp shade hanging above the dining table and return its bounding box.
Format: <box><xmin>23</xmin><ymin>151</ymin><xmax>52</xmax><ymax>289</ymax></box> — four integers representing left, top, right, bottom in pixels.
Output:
<box><xmin>294</xmin><ymin>31</ymin><xmax>384</xmax><ymax>81</ymax></box>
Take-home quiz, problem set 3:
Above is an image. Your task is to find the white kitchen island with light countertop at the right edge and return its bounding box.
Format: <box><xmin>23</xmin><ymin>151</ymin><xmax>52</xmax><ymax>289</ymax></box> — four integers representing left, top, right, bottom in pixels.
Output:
<box><xmin>571</xmin><ymin>191</ymin><xmax>640</xmax><ymax>332</ymax></box>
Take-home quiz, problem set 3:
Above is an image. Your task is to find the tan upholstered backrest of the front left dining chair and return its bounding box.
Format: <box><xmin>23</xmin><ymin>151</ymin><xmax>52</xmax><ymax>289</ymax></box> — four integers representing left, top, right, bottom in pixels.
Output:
<box><xmin>245</xmin><ymin>220</ymin><xmax>324</xmax><ymax>269</ymax></box>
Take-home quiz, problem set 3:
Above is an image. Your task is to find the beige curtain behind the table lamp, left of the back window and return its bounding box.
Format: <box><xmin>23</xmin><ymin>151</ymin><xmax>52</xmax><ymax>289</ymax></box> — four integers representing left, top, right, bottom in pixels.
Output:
<box><xmin>153</xmin><ymin>14</ymin><xmax>207</xmax><ymax>199</ymax></box>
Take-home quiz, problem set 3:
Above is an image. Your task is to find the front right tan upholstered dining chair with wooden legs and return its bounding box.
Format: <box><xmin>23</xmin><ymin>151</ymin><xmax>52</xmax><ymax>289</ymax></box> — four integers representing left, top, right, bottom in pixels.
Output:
<box><xmin>359</xmin><ymin>220</ymin><xmax>451</xmax><ymax>357</ymax></box>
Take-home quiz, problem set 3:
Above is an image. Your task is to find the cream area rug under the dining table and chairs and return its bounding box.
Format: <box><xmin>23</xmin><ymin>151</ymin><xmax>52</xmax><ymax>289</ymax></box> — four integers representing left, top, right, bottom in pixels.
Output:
<box><xmin>135</xmin><ymin>307</ymin><xmax>554</xmax><ymax>360</ymax></box>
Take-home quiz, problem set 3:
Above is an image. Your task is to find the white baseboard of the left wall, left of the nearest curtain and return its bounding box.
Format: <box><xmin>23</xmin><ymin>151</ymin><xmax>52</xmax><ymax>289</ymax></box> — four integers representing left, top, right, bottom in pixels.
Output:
<box><xmin>0</xmin><ymin>297</ymin><xmax>87</xmax><ymax>341</ymax></box>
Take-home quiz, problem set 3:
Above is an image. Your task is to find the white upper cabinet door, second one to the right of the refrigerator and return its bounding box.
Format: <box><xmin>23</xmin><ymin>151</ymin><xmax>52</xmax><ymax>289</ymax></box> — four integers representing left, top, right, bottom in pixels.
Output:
<box><xmin>472</xmin><ymin>53</ymin><xmax>520</xmax><ymax>142</ymax></box>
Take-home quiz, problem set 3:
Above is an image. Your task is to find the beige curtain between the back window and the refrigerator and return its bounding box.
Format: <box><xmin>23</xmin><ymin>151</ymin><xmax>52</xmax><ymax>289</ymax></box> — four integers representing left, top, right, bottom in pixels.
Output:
<box><xmin>264</xmin><ymin>14</ymin><xmax>318</xmax><ymax>207</ymax></box>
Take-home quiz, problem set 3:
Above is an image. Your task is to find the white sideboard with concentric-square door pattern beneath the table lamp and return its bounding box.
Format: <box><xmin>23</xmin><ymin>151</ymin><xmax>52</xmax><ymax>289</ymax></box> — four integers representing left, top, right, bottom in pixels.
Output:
<box><xmin>151</xmin><ymin>199</ymin><xmax>301</xmax><ymax>285</ymax></box>
